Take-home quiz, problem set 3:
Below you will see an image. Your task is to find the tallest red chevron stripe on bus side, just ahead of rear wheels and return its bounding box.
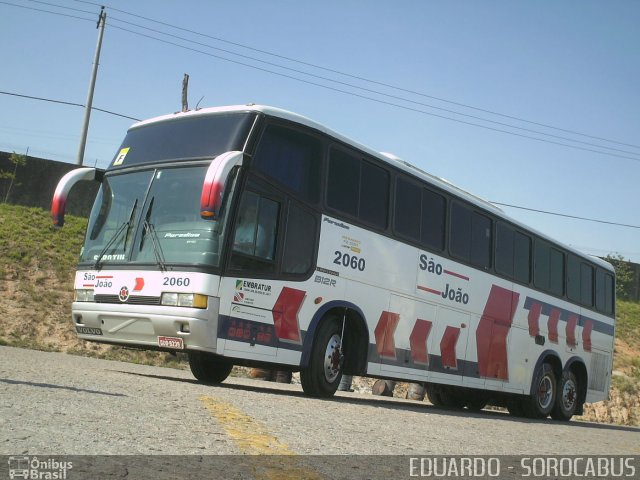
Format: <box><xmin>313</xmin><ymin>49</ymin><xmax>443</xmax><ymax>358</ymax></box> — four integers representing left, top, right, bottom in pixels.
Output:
<box><xmin>476</xmin><ymin>285</ymin><xmax>520</xmax><ymax>380</ymax></box>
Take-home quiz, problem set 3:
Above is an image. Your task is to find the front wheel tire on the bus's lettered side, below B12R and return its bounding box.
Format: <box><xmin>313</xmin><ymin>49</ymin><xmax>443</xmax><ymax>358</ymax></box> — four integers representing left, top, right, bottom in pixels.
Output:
<box><xmin>300</xmin><ymin>318</ymin><xmax>343</xmax><ymax>398</ymax></box>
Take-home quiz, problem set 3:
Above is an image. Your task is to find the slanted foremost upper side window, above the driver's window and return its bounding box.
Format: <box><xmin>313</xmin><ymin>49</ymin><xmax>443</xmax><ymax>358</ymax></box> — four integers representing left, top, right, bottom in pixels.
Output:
<box><xmin>252</xmin><ymin>125</ymin><xmax>322</xmax><ymax>203</ymax></box>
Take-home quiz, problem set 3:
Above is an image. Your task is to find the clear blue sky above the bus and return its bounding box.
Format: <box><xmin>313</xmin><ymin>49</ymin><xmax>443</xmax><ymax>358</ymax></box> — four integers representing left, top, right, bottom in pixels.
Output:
<box><xmin>0</xmin><ymin>0</ymin><xmax>640</xmax><ymax>263</ymax></box>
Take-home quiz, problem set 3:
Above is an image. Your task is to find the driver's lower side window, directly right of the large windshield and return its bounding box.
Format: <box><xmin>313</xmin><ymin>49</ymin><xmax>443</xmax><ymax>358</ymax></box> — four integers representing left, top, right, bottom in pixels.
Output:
<box><xmin>231</xmin><ymin>191</ymin><xmax>280</xmax><ymax>272</ymax></box>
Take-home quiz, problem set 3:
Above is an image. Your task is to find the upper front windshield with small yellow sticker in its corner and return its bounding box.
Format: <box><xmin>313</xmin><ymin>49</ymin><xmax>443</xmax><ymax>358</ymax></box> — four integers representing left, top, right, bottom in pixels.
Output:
<box><xmin>109</xmin><ymin>112</ymin><xmax>255</xmax><ymax>169</ymax></box>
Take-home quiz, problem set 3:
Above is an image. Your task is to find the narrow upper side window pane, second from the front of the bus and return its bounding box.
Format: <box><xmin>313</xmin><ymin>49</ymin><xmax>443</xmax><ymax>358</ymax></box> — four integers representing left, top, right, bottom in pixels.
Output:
<box><xmin>327</xmin><ymin>149</ymin><xmax>360</xmax><ymax>217</ymax></box>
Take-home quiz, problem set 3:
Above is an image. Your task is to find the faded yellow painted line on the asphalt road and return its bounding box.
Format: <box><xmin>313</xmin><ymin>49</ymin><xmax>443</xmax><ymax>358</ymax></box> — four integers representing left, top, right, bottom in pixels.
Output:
<box><xmin>199</xmin><ymin>396</ymin><xmax>323</xmax><ymax>480</ymax></box>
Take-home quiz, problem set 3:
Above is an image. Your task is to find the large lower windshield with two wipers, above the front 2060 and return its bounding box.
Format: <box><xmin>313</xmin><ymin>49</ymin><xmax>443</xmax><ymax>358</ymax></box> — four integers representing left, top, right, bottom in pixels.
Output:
<box><xmin>81</xmin><ymin>165</ymin><xmax>233</xmax><ymax>268</ymax></box>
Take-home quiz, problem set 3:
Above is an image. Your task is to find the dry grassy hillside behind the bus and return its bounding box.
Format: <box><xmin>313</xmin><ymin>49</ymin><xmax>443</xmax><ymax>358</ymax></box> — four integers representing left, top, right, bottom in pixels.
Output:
<box><xmin>0</xmin><ymin>204</ymin><xmax>640</xmax><ymax>425</ymax></box>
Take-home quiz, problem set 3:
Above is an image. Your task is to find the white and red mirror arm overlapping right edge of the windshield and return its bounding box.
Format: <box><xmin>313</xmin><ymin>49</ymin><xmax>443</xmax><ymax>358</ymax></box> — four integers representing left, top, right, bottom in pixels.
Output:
<box><xmin>200</xmin><ymin>151</ymin><xmax>243</xmax><ymax>220</ymax></box>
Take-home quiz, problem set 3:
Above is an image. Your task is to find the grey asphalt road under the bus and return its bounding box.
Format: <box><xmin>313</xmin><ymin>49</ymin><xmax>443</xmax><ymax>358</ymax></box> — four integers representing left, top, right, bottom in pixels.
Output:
<box><xmin>0</xmin><ymin>347</ymin><xmax>640</xmax><ymax>478</ymax></box>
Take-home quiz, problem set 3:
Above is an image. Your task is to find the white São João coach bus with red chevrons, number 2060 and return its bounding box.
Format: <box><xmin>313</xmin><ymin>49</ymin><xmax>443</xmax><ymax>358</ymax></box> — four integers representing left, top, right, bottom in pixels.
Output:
<box><xmin>52</xmin><ymin>104</ymin><xmax>615</xmax><ymax>420</ymax></box>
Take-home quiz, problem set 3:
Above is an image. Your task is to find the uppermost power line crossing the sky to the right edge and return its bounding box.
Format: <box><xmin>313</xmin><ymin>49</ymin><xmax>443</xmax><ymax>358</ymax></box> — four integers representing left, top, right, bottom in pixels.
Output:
<box><xmin>70</xmin><ymin>0</ymin><xmax>640</xmax><ymax>149</ymax></box>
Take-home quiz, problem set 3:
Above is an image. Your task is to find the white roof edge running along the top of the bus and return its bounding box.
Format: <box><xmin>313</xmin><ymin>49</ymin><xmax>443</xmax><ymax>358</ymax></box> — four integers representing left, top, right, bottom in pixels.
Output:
<box><xmin>131</xmin><ymin>104</ymin><xmax>613</xmax><ymax>271</ymax></box>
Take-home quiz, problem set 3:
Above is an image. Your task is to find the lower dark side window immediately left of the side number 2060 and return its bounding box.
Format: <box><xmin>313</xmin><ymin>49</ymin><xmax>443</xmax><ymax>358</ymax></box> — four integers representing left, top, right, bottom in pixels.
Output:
<box><xmin>282</xmin><ymin>202</ymin><xmax>318</xmax><ymax>274</ymax></box>
